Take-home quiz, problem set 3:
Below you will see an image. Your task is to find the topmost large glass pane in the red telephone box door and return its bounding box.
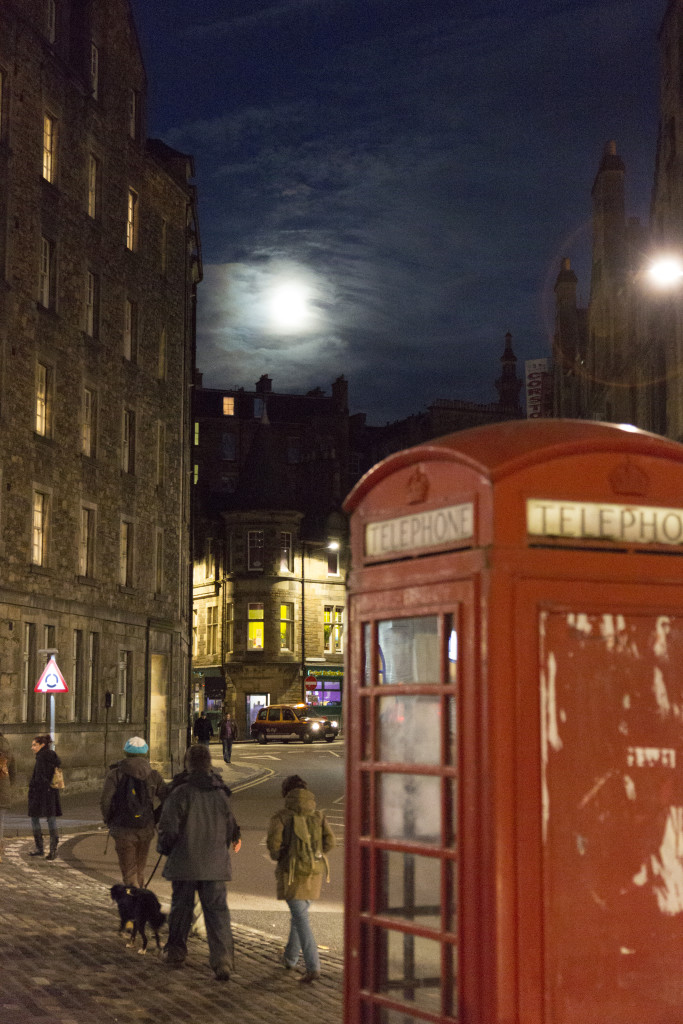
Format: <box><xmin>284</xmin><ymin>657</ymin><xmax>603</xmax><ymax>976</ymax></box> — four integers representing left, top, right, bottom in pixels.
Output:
<box><xmin>377</xmin><ymin>615</ymin><xmax>441</xmax><ymax>684</ymax></box>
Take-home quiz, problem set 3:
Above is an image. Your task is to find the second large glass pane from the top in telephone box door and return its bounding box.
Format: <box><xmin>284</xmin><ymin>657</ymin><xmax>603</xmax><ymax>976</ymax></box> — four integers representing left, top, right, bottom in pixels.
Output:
<box><xmin>377</xmin><ymin>694</ymin><xmax>441</xmax><ymax>765</ymax></box>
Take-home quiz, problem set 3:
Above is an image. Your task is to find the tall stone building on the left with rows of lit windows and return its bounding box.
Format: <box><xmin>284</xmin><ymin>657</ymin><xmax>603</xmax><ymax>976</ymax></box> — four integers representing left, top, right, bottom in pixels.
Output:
<box><xmin>0</xmin><ymin>0</ymin><xmax>201</xmax><ymax>786</ymax></box>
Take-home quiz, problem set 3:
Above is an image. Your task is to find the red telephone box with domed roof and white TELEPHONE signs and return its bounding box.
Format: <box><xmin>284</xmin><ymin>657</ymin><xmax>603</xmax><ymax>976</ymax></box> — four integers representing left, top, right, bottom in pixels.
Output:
<box><xmin>344</xmin><ymin>420</ymin><xmax>683</xmax><ymax>1024</ymax></box>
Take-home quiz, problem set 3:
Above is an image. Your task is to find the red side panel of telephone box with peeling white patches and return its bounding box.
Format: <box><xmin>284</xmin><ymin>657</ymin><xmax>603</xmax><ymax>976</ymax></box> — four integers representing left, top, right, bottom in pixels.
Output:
<box><xmin>540</xmin><ymin>610</ymin><xmax>683</xmax><ymax>1024</ymax></box>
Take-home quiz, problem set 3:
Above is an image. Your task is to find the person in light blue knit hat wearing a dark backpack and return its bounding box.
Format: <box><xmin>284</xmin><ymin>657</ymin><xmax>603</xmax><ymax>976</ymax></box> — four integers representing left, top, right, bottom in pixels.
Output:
<box><xmin>99</xmin><ymin>736</ymin><xmax>166</xmax><ymax>889</ymax></box>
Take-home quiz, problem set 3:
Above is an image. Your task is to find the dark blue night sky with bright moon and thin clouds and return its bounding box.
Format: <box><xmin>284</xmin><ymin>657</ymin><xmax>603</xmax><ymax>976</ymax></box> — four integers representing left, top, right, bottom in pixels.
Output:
<box><xmin>133</xmin><ymin>0</ymin><xmax>666</xmax><ymax>424</ymax></box>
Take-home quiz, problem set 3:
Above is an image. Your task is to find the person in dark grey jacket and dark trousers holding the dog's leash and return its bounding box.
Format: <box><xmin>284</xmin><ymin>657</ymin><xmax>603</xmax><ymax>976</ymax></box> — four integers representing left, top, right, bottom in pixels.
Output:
<box><xmin>157</xmin><ymin>743</ymin><xmax>242</xmax><ymax>981</ymax></box>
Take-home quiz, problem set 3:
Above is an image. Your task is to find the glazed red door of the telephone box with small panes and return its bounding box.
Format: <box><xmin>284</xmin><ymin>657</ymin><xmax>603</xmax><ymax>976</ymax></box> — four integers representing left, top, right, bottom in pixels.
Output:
<box><xmin>346</xmin><ymin>582</ymin><xmax>478</xmax><ymax>1024</ymax></box>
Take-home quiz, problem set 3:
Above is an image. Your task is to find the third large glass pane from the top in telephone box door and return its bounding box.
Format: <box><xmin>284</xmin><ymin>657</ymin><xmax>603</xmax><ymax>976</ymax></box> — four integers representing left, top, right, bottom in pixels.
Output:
<box><xmin>377</xmin><ymin>772</ymin><xmax>441</xmax><ymax>844</ymax></box>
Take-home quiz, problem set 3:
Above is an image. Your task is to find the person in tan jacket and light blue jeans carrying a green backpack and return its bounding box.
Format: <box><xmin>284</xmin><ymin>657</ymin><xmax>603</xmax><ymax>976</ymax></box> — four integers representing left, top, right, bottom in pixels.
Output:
<box><xmin>266</xmin><ymin>775</ymin><xmax>335</xmax><ymax>983</ymax></box>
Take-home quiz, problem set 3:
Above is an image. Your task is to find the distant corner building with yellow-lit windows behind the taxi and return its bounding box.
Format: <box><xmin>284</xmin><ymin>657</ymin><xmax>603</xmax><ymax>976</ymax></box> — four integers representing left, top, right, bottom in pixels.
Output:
<box><xmin>193</xmin><ymin>375</ymin><xmax>352</xmax><ymax>735</ymax></box>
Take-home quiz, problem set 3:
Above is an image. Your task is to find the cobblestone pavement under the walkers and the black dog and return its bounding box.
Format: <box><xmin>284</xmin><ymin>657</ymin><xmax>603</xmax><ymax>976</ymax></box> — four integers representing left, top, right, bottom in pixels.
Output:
<box><xmin>0</xmin><ymin>837</ymin><xmax>342</xmax><ymax>1024</ymax></box>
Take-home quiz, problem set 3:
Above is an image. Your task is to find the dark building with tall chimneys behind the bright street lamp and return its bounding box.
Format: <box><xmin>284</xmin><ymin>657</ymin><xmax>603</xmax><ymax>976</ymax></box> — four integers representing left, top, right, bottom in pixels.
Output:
<box><xmin>553</xmin><ymin>0</ymin><xmax>683</xmax><ymax>440</ymax></box>
